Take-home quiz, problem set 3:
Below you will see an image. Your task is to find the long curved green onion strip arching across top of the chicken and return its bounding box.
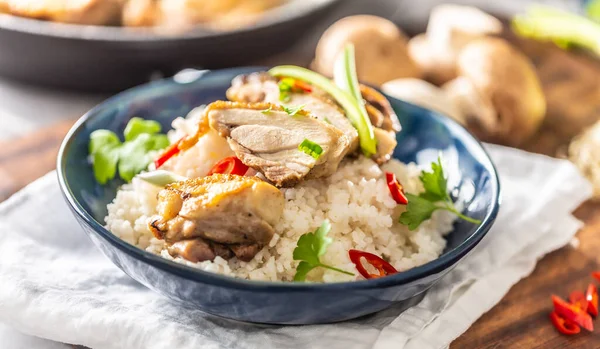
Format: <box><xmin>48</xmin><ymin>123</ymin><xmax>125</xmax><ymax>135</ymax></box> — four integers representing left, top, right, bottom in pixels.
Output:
<box><xmin>269</xmin><ymin>65</ymin><xmax>377</xmax><ymax>156</ymax></box>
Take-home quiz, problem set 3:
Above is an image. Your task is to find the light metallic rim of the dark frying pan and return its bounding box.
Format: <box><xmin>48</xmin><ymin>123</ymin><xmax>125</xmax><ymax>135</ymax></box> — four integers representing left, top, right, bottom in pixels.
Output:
<box><xmin>0</xmin><ymin>0</ymin><xmax>341</xmax><ymax>42</ymax></box>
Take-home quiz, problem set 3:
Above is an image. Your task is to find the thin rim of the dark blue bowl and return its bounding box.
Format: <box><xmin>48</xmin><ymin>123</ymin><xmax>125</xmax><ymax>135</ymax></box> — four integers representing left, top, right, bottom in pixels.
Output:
<box><xmin>56</xmin><ymin>67</ymin><xmax>501</xmax><ymax>292</ymax></box>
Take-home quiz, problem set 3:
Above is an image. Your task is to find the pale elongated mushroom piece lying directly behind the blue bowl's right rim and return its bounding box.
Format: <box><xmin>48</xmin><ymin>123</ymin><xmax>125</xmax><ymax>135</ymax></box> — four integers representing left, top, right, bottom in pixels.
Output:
<box><xmin>381</xmin><ymin>78</ymin><xmax>466</xmax><ymax>125</ymax></box>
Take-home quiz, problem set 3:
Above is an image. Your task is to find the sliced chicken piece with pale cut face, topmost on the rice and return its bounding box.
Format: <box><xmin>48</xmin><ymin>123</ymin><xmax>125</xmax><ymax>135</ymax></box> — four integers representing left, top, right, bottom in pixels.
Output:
<box><xmin>206</xmin><ymin>101</ymin><xmax>350</xmax><ymax>187</ymax></box>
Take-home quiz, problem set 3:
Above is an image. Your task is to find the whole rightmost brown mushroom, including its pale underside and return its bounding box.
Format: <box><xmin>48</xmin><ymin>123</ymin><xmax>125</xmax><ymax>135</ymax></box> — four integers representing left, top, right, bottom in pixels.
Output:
<box><xmin>443</xmin><ymin>37</ymin><xmax>546</xmax><ymax>146</ymax></box>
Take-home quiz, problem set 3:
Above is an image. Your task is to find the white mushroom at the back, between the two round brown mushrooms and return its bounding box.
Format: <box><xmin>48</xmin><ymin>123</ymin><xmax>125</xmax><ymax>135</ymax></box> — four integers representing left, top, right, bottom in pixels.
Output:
<box><xmin>408</xmin><ymin>4</ymin><xmax>502</xmax><ymax>85</ymax></box>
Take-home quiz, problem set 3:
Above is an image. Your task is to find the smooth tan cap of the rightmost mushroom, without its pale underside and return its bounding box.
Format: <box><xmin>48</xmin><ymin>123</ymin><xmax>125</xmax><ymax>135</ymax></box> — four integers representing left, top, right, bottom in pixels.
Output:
<box><xmin>457</xmin><ymin>37</ymin><xmax>546</xmax><ymax>146</ymax></box>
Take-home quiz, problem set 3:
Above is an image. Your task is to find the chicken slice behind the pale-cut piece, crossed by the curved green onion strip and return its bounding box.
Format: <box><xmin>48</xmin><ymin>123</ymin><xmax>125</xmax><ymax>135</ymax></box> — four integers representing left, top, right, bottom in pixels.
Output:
<box><xmin>227</xmin><ymin>72</ymin><xmax>358</xmax><ymax>153</ymax></box>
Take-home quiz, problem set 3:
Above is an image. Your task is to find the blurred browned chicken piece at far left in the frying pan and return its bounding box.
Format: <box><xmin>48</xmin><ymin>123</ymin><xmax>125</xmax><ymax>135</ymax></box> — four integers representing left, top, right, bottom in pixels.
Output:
<box><xmin>2</xmin><ymin>0</ymin><xmax>122</xmax><ymax>25</ymax></box>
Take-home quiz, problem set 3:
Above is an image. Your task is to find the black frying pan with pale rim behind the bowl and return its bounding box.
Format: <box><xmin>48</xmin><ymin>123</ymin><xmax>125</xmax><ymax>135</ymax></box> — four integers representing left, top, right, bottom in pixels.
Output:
<box><xmin>0</xmin><ymin>0</ymin><xmax>338</xmax><ymax>92</ymax></box>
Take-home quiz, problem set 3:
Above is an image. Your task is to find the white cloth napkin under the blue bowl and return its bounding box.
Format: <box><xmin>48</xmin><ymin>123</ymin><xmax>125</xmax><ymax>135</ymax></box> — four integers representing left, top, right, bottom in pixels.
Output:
<box><xmin>0</xmin><ymin>146</ymin><xmax>591</xmax><ymax>349</ymax></box>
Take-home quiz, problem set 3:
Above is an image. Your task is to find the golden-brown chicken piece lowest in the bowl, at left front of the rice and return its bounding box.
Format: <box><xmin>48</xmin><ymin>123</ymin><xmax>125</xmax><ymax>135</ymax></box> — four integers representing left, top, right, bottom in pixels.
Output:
<box><xmin>149</xmin><ymin>174</ymin><xmax>284</xmax><ymax>261</ymax></box>
